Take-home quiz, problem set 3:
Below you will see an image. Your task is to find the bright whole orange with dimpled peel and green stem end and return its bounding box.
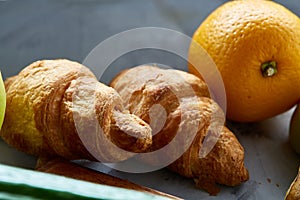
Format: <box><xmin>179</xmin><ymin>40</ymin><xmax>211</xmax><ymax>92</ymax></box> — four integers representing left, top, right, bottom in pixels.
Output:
<box><xmin>189</xmin><ymin>0</ymin><xmax>300</xmax><ymax>122</ymax></box>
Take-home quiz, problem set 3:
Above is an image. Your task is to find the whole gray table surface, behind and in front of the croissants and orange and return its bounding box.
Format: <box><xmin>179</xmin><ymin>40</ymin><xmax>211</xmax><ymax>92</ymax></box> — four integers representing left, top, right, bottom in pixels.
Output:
<box><xmin>0</xmin><ymin>0</ymin><xmax>300</xmax><ymax>199</ymax></box>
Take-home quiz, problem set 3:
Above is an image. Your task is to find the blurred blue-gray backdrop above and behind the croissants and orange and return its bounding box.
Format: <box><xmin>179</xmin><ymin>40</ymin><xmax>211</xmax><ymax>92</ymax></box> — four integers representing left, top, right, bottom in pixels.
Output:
<box><xmin>0</xmin><ymin>0</ymin><xmax>300</xmax><ymax>77</ymax></box>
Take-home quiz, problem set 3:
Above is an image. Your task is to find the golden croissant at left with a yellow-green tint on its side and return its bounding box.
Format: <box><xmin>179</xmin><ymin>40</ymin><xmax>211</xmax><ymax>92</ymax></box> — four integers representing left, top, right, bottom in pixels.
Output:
<box><xmin>1</xmin><ymin>59</ymin><xmax>152</xmax><ymax>162</ymax></box>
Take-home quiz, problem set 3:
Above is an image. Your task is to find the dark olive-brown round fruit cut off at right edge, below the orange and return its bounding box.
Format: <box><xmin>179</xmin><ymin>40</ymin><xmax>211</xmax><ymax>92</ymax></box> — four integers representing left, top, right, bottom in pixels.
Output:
<box><xmin>289</xmin><ymin>104</ymin><xmax>300</xmax><ymax>154</ymax></box>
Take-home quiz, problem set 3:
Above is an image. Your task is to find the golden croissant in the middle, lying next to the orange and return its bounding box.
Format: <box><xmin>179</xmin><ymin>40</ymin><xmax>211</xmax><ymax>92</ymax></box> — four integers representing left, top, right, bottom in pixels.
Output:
<box><xmin>111</xmin><ymin>66</ymin><xmax>249</xmax><ymax>195</ymax></box>
